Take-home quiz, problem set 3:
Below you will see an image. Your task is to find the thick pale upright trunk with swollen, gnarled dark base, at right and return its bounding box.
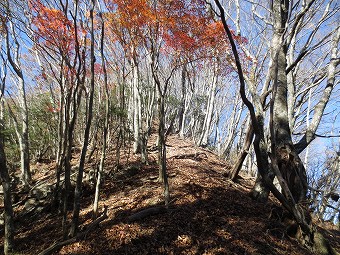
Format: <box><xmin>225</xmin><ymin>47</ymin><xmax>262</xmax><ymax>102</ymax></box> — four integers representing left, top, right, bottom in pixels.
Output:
<box><xmin>271</xmin><ymin>0</ymin><xmax>307</xmax><ymax>203</ymax></box>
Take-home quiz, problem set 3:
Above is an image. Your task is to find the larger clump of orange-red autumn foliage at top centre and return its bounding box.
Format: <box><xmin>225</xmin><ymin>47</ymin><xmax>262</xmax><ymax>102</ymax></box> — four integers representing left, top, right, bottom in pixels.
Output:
<box><xmin>106</xmin><ymin>0</ymin><xmax>247</xmax><ymax>60</ymax></box>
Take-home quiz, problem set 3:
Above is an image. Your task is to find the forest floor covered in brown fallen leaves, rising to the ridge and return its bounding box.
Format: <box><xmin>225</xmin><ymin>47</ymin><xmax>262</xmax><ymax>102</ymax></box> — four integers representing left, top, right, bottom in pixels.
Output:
<box><xmin>0</xmin><ymin>136</ymin><xmax>340</xmax><ymax>255</ymax></box>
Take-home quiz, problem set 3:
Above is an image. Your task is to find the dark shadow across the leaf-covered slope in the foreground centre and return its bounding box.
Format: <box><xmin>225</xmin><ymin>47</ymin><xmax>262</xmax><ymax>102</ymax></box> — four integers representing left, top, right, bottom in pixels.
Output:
<box><xmin>67</xmin><ymin>183</ymin><xmax>309</xmax><ymax>254</ymax></box>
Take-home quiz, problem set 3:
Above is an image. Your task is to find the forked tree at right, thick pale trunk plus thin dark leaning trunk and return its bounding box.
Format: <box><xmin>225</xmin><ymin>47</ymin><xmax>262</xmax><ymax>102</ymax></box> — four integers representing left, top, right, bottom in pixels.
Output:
<box><xmin>215</xmin><ymin>0</ymin><xmax>334</xmax><ymax>254</ymax></box>
